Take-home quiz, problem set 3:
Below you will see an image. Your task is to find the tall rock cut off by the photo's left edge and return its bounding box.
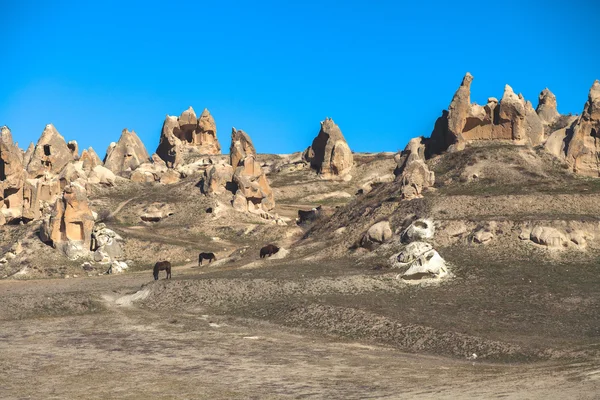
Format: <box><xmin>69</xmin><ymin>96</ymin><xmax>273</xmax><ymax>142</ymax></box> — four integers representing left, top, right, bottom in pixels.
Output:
<box><xmin>0</xmin><ymin>126</ymin><xmax>26</xmax><ymax>225</ymax></box>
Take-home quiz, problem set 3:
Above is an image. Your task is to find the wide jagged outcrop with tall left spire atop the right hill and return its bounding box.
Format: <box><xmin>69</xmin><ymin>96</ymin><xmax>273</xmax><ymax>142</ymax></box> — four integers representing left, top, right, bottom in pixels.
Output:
<box><xmin>426</xmin><ymin>73</ymin><xmax>544</xmax><ymax>157</ymax></box>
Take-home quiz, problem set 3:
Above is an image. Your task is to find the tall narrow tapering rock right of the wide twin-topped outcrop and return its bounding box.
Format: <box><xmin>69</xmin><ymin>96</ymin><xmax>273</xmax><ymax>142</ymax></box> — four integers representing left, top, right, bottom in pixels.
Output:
<box><xmin>230</xmin><ymin>128</ymin><xmax>275</xmax><ymax>214</ymax></box>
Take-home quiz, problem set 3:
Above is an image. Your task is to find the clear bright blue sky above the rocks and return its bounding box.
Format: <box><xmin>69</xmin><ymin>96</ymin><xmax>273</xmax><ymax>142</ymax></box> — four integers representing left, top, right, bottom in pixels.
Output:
<box><xmin>0</xmin><ymin>0</ymin><xmax>600</xmax><ymax>156</ymax></box>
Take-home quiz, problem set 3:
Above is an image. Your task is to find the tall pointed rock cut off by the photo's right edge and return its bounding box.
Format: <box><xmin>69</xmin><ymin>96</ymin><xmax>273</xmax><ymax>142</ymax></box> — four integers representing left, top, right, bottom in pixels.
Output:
<box><xmin>565</xmin><ymin>81</ymin><xmax>600</xmax><ymax>176</ymax></box>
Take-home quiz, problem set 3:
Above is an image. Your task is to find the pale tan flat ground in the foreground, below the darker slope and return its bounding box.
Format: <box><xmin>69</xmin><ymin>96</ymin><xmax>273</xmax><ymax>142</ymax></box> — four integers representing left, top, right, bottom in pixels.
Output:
<box><xmin>0</xmin><ymin>272</ymin><xmax>600</xmax><ymax>399</ymax></box>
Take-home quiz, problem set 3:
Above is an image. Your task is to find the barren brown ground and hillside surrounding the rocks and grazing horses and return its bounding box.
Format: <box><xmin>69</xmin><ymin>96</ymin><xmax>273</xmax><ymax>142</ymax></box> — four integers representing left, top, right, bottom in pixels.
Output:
<box><xmin>0</xmin><ymin>145</ymin><xmax>600</xmax><ymax>399</ymax></box>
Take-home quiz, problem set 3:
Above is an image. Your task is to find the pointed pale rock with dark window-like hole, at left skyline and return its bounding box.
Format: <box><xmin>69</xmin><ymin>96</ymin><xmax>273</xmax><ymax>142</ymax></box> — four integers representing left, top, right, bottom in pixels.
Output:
<box><xmin>27</xmin><ymin>124</ymin><xmax>73</xmax><ymax>178</ymax></box>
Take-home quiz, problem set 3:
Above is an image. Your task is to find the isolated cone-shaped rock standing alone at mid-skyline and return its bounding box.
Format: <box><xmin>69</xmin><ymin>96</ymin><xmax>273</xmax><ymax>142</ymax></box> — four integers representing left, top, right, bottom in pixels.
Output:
<box><xmin>304</xmin><ymin>118</ymin><xmax>354</xmax><ymax>179</ymax></box>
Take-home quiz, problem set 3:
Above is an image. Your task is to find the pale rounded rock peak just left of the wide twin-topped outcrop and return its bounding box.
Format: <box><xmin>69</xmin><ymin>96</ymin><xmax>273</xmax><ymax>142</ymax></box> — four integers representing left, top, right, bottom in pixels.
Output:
<box><xmin>104</xmin><ymin>129</ymin><xmax>150</xmax><ymax>176</ymax></box>
